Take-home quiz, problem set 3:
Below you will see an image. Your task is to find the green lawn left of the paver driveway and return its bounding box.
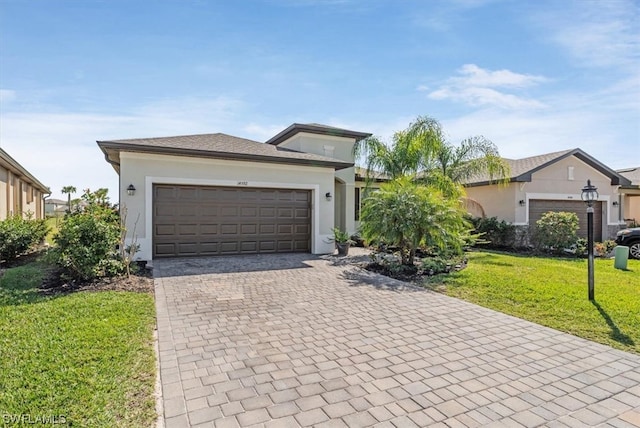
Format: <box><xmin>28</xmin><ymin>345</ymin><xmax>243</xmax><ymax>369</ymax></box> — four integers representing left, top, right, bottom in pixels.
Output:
<box><xmin>0</xmin><ymin>263</ymin><xmax>156</xmax><ymax>427</ymax></box>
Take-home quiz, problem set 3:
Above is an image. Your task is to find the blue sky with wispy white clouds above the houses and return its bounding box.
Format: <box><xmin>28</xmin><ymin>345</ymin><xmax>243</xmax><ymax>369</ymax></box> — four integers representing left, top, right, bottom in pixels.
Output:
<box><xmin>0</xmin><ymin>0</ymin><xmax>640</xmax><ymax>201</ymax></box>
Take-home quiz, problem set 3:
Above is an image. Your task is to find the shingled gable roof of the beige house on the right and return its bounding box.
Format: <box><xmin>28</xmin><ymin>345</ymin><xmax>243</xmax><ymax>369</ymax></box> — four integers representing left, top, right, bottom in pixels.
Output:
<box><xmin>465</xmin><ymin>149</ymin><xmax>631</xmax><ymax>187</ymax></box>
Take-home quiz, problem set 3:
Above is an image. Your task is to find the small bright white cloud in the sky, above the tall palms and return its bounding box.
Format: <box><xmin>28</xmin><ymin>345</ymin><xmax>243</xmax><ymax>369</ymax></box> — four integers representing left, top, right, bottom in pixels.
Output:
<box><xmin>428</xmin><ymin>64</ymin><xmax>547</xmax><ymax>110</ymax></box>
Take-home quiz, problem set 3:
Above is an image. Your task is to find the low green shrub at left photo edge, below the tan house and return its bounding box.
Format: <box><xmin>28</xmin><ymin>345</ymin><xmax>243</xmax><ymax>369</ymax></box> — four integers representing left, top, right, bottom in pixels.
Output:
<box><xmin>0</xmin><ymin>215</ymin><xmax>49</xmax><ymax>261</ymax></box>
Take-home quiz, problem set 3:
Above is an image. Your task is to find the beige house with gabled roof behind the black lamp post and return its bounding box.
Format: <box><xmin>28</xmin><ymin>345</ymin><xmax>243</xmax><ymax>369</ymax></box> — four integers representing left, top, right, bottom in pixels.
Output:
<box><xmin>465</xmin><ymin>149</ymin><xmax>638</xmax><ymax>241</ymax></box>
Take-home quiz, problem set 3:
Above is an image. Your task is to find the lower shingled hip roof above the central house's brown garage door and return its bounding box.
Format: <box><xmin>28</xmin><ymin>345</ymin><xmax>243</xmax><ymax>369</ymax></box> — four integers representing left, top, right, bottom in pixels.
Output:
<box><xmin>97</xmin><ymin>133</ymin><xmax>353</xmax><ymax>172</ymax></box>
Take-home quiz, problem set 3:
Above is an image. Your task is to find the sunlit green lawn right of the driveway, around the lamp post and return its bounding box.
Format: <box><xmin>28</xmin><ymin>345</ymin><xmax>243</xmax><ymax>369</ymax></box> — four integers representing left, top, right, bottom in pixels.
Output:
<box><xmin>425</xmin><ymin>252</ymin><xmax>640</xmax><ymax>354</ymax></box>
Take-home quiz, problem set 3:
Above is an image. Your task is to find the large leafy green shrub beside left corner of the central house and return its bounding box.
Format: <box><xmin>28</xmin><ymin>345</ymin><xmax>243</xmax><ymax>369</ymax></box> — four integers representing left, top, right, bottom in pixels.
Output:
<box><xmin>54</xmin><ymin>190</ymin><xmax>132</xmax><ymax>281</ymax></box>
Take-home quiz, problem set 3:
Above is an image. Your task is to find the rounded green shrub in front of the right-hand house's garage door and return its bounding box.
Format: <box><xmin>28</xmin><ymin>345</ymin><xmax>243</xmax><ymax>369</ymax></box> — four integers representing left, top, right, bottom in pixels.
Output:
<box><xmin>533</xmin><ymin>211</ymin><xmax>580</xmax><ymax>252</ymax></box>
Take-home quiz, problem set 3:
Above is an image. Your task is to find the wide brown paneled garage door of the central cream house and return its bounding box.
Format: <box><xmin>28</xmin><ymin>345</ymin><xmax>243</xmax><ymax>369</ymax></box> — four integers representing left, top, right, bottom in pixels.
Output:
<box><xmin>153</xmin><ymin>184</ymin><xmax>311</xmax><ymax>257</ymax></box>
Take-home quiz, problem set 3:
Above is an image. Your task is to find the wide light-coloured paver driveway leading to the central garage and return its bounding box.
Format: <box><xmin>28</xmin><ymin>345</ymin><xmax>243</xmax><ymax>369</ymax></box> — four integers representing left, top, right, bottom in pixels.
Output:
<box><xmin>154</xmin><ymin>254</ymin><xmax>640</xmax><ymax>427</ymax></box>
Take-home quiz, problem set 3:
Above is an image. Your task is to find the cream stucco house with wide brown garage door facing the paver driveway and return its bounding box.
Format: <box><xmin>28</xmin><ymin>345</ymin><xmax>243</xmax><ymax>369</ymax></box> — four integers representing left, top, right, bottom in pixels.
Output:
<box><xmin>98</xmin><ymin>124</ymin><xmax>370</xmax><ymax>260</ymax></box>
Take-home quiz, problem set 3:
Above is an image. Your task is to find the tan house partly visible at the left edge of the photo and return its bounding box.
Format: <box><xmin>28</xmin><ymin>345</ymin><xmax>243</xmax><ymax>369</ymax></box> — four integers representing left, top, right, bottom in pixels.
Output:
<box><xmin>0</xmin><ymin>148</ymin><xmax>51</xmax><ymax>220</ymax></box>
